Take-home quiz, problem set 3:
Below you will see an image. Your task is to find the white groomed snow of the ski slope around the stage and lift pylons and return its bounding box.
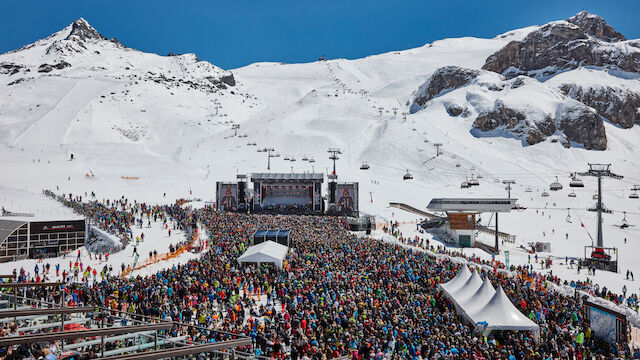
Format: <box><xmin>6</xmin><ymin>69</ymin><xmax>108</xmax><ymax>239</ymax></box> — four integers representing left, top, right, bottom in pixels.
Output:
<box><xmin>0</xmin><ymin>16</ymin><xmax>640</xmax><ymax>294</ymax></box>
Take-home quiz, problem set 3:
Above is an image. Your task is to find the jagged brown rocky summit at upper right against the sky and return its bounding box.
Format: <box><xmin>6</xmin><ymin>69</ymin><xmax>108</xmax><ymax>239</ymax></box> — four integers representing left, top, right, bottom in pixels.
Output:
<box><xmin>482</xmin><ymin>12</ymin><xmax>640</xmax><ymax>78</ymax></box>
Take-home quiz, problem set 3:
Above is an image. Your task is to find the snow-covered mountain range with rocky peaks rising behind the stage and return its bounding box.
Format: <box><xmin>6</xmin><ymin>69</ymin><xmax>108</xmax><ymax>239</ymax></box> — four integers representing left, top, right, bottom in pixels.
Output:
<box><xmin>0</xmin><ymin>13</ymin><xmax>640</xmax><ymax>219</ymax></box>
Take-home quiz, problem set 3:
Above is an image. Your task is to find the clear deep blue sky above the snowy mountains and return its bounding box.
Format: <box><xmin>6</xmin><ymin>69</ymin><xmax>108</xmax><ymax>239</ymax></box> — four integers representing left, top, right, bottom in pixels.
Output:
<box><xmin>0</xmin><ymin>0</ymin><xmax>640</xmax><ymax>69</ymax></box>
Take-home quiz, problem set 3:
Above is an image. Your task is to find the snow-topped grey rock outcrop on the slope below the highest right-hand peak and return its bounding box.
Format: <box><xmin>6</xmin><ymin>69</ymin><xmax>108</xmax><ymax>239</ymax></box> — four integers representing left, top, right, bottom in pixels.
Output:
<box><xmin>411</xmin><ymin>66</ymin><xmax>607</xmax><ymax>150</ymax></box>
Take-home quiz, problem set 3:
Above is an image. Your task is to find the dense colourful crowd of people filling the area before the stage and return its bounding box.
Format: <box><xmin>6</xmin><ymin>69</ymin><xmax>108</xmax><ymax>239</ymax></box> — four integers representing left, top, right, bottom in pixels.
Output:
<box><xmin>1</xmin><ymin>195</ymin><xmax>637</xmax><ymax>360</ymax></box>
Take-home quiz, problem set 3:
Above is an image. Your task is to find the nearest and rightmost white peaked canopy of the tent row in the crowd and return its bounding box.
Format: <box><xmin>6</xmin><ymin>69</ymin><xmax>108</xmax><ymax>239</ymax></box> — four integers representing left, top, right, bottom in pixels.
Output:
<box><xmin>469</xmin><ymin>286</ymin><xmax>540</xmax><ymax>339</ymax></box>
